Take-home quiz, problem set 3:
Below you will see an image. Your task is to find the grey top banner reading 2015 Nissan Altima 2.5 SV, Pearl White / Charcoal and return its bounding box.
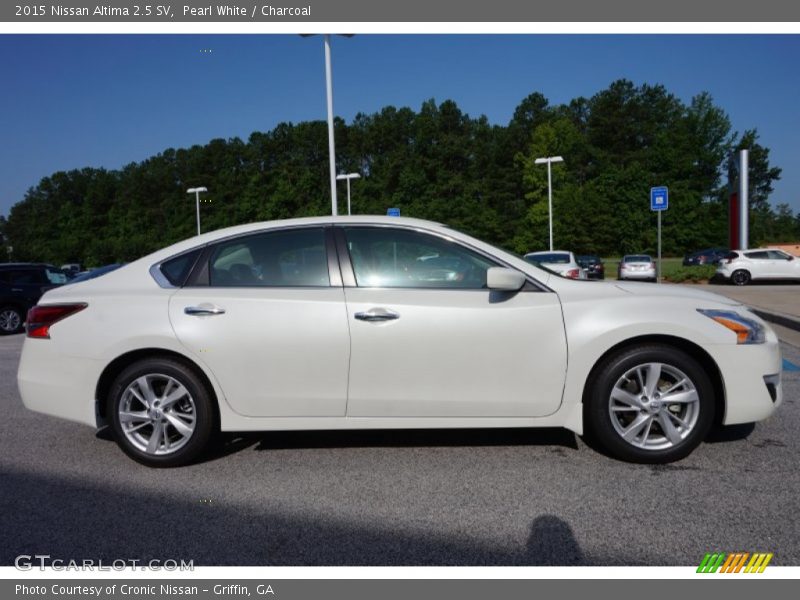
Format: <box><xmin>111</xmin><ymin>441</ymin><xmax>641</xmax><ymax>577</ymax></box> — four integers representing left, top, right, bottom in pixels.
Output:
<box><xmin>0</xmin><ymin>0</ymin><xmax>800</xmax><ymax>23</ymax></box>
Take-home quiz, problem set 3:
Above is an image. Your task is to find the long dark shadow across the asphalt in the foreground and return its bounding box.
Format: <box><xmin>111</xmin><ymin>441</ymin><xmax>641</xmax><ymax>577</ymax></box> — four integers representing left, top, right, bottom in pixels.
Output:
<box><xmin>0</xmin><ymin>469</ymin><xmax>636</xmax><ymax>566</ymax></box>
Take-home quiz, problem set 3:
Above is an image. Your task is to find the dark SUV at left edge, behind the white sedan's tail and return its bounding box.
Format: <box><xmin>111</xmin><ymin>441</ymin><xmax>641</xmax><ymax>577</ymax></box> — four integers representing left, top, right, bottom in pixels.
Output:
<box><xmin>0</xmin><ymin>263</ymin><xmax>68</xmax><ymax>335</ymax></box>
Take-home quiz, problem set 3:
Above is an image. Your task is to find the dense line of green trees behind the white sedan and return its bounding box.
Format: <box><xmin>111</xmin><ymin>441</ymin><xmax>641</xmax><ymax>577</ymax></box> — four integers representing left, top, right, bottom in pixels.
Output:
<box><xmin>0</xmin><ymin>80</ymin><xmax>800</xmax><ymax>265</ymax></box>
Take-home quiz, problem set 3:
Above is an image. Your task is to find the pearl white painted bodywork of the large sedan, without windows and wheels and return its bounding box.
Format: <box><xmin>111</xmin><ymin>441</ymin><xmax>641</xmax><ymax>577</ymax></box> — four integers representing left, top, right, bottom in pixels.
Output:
<box><xmin>18</xmin><ymin>217</ymin><xmax>781</xmax><ymax>440</ymax></box>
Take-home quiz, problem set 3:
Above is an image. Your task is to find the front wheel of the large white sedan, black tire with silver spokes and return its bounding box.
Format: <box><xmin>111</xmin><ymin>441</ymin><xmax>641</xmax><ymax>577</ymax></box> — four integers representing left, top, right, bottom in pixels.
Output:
<box><xmin>584</xmin><ymin>345</ymin><xmax>714</xmax><ymax>464</ymax></box>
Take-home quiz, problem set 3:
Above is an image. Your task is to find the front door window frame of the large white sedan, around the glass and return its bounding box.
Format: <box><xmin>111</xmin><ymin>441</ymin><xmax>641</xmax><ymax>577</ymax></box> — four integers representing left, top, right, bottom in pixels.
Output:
<box><xmin>333</xmin><ymin>223</ymin><xmax>553</xmax><ymax>293</ymax></box>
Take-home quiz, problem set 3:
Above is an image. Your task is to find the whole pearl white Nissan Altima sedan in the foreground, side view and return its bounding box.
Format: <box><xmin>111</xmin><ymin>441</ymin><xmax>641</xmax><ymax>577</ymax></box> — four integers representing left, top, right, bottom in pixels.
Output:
<box><xmin>18</xmin><ymin>217</ymin><xmax>781</xmax><ymax>466</ymax></box>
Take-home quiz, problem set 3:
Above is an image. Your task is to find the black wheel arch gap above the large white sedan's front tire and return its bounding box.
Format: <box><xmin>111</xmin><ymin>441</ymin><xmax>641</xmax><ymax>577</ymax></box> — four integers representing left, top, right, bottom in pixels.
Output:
<box><xmin>581</xmin><ymin>334</ymin><xmax>726</xmax><ymax>425</ymax></box>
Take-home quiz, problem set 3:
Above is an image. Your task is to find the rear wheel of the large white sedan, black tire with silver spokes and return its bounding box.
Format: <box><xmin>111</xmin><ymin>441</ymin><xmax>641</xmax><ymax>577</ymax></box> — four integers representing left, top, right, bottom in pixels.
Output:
<box><xmin>106</xmin><ymin>358</ymin><xmax>216</xmax><ymax>467</ymax></box>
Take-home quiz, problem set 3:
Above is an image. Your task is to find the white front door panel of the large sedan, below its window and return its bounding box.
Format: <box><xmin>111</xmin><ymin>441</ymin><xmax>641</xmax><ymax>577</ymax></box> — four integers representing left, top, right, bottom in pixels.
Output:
<box><xmin>345</xmin><ymin>288</ymin><xmax>567</xmax><ymax>417</ymax></box>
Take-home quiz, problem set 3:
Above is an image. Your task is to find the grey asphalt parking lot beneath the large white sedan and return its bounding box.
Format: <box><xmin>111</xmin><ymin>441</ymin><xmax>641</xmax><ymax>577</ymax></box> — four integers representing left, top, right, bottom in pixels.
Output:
<box><xmin>0</xmin><ymin>336</ymin><xmax>800</xmax><ymax>565</ymax></box>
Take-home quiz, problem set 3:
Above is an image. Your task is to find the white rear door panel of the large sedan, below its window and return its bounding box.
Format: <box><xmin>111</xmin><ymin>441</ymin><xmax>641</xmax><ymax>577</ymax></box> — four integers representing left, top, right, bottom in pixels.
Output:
<box><xmin>169</xmin><ymin>287</ymin><xmax>350</xmax><ymax>417</ymax></box>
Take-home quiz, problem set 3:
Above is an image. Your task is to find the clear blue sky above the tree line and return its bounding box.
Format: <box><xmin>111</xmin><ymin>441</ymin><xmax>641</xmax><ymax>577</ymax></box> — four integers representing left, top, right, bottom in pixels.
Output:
<box><xmin>0</xmin><ymin>34</ymin><xmax>800</xmax><ymax>214</ymax></box>
